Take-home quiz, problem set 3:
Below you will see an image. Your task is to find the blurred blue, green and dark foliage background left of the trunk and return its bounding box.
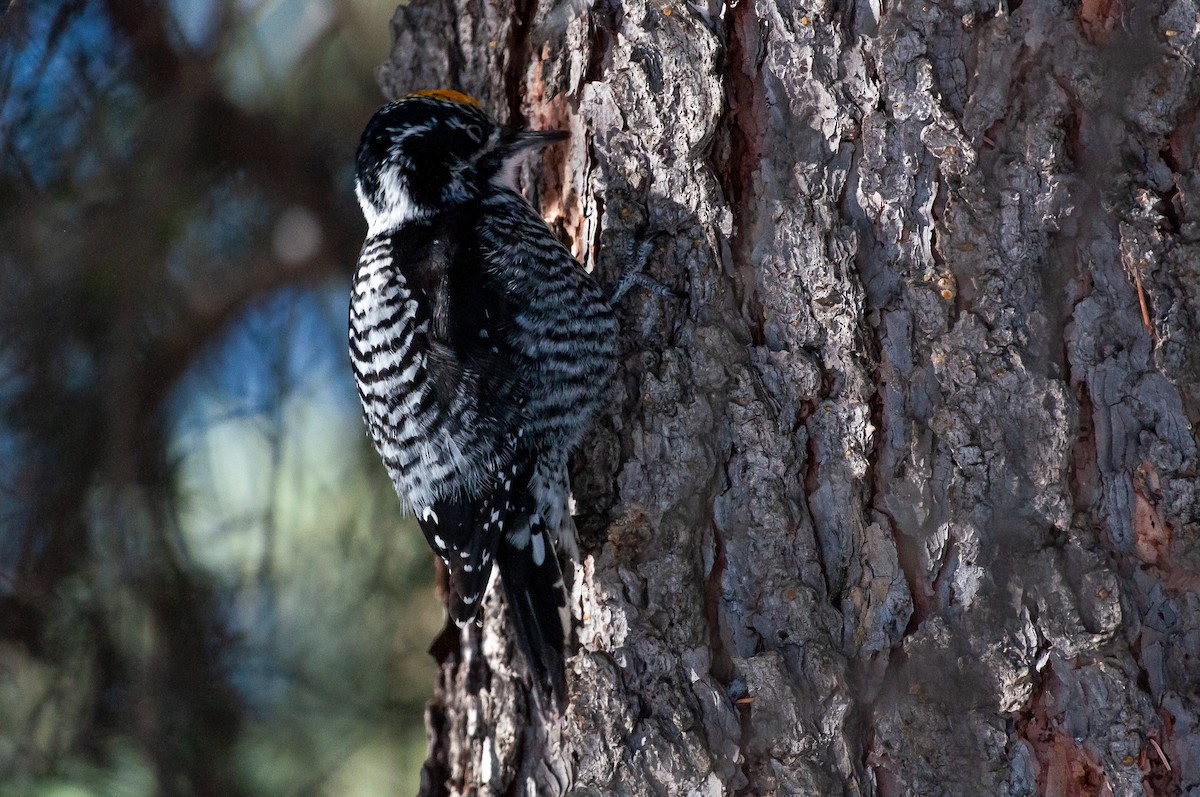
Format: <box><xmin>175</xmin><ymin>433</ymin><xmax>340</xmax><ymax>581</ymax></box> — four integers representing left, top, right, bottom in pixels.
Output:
<box><xmin>0</xmin><ymin>0</ymin><xmax>442</xmax><ymax>797</ymax></box>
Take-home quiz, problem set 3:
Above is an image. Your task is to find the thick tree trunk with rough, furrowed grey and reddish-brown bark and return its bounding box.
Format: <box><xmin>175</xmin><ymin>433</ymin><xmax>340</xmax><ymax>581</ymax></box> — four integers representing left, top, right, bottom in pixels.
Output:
<box><xmin>380</xmin><ymin>0</ymin><xmax>1200</xmax><ymax>795</ymax></box>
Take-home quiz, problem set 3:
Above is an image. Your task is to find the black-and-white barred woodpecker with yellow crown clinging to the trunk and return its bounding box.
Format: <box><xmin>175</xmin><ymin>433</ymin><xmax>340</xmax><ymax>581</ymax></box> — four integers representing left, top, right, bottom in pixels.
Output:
<box><xmin>349</xmin><ymin>90</ymin><xmax>617</xmax><ymax>701</ymax></box>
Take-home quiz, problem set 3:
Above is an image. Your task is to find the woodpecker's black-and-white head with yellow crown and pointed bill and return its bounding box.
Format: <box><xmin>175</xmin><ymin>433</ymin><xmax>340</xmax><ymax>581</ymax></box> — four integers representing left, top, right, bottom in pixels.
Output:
<box><xmin>354</xmin><ymin>90</ymin><xmax>566</xmax><ymax>235</ymax></box>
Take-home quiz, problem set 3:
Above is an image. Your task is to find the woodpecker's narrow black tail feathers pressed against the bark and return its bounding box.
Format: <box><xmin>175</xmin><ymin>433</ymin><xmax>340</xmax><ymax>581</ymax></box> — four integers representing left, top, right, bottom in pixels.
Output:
<box><xmin>496</xmin><ymin>525</ymin><xmax>570</xmax><ymax>711</ymax></box>
